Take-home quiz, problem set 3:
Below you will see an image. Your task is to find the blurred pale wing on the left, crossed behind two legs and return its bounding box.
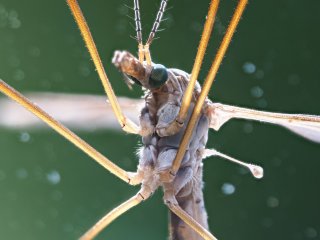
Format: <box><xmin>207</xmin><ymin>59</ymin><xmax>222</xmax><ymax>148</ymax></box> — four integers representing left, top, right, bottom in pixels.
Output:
<box><xmin>0</xmin><ymin>93</ymin><xmax>143</xmax><ymax>131</ymax></box>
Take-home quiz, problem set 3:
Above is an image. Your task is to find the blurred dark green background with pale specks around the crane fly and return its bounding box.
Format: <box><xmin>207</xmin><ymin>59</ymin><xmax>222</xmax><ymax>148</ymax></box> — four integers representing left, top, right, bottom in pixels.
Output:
<box><xmin>0</xmin><ymin>0</ymin><xmax>320</xmax><ymax>240</ymax></box>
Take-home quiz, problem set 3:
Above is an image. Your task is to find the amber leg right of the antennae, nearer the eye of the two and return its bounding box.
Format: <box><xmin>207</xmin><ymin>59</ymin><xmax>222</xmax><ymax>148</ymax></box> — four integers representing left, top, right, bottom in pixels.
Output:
<box><xmin>161</xmin><ymin>0</ymin><xmax>219</xmax><ymax>134</ymax></box>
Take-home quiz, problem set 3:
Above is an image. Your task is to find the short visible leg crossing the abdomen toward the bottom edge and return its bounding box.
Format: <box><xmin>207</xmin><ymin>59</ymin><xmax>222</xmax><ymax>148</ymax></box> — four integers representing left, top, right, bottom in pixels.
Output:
<box><xmin>165</xmin><ymin>196</ymin><xmax>217</xmax><ymax>240</ymax></box>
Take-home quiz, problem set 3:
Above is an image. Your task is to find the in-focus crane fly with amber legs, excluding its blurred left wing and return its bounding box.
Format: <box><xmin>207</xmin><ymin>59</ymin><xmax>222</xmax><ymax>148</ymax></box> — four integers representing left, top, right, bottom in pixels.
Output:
<box><xmin>0</xmin><ymin>0</ymin><xmax>320</xmax><ymax>239</ymax></box>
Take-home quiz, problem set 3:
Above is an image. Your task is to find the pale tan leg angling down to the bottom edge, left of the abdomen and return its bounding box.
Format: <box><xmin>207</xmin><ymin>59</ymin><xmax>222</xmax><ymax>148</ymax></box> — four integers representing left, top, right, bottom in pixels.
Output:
<box><xmin>80</xmin><ymin>188</ymin><xmax>151</xmax><ymax>240</ymax></box>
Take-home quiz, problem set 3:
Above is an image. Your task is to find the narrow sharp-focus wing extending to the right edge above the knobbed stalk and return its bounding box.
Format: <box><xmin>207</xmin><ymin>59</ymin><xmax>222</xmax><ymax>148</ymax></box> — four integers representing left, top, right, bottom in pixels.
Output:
<box><xmin>208</xmin><ymin>103</ymin><xmax>320</xmax><ymax>143</ymax></box>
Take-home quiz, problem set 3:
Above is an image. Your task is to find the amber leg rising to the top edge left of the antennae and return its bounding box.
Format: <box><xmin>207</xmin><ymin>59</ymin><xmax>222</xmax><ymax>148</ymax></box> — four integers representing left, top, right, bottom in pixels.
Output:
<box><xmin>67</xmin><ymin>0</ymin><xmax>139</xmax><ymax>134</ymax></box>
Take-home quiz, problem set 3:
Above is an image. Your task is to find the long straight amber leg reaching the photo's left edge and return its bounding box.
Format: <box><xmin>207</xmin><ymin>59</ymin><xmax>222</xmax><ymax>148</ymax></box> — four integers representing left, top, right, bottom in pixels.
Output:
<box><xmin>0</xmin><ymin>80</ymin><xmax>136</xmax><ymax>183</ymax></box>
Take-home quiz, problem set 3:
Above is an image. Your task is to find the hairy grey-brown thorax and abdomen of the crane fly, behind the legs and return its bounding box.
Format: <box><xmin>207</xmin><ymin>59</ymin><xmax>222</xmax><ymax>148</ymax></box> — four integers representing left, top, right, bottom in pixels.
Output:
<box><xmin>138</xmin><ymin>69</ymin><xmax>209</xmax><ymax>239</ymax></box>
